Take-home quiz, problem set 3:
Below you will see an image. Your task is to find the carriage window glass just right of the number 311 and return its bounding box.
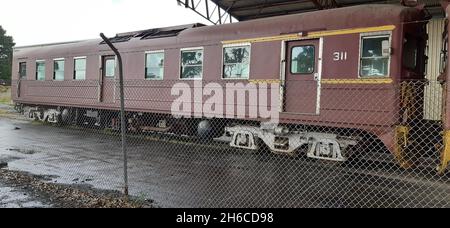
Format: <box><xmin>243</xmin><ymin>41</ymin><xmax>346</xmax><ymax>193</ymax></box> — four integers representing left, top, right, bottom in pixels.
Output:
<box><xmin>360</xmin><ymin>35</ymin><xmax>390</xmax><ymax>77</ymax></box>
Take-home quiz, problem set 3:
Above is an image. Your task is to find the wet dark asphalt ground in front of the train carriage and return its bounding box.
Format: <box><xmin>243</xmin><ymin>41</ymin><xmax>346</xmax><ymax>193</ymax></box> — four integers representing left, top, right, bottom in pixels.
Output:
<box><xmin>0</xmin><ymin>108</ymin><xmax>450</xmax><ymax>207</ymax></box>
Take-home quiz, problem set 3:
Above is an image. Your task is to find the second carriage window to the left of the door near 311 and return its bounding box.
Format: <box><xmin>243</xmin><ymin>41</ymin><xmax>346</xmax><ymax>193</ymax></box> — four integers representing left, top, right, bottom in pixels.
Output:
<box><xmin>181</xmin><ymin>49</ymin><xmax>203</xmax><ymax>79</ymax></box>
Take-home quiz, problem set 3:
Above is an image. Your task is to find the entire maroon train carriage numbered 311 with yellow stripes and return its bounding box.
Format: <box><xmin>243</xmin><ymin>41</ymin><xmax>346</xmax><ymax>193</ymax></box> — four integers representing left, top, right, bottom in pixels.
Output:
<box><xmin>13</xmin><ymin>5</ymin><xmax>450</xmax><ymax>170</ymax></box>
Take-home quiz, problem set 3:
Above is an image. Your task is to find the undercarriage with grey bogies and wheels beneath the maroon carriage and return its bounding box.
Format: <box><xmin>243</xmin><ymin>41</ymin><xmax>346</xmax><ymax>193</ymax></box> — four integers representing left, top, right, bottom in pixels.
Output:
<box><xmin>16</xmin><ymin>105</ymin><xmax>370</xmax><ymax>162</ymax></box>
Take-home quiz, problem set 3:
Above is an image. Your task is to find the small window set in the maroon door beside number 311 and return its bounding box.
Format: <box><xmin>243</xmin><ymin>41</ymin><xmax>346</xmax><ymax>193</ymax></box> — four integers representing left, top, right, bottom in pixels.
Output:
<box><xmin>291</xmin><ymin>45</ymin><xmax>316</xmax><ymax>74</ymax></box>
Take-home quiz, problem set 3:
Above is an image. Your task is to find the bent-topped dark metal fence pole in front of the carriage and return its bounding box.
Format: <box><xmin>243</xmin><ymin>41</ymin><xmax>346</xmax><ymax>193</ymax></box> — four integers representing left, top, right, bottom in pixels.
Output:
<box><xmin>100</xmin><ymin>33</ymin><xmax>128</xmax><ymax>196</ymax></box>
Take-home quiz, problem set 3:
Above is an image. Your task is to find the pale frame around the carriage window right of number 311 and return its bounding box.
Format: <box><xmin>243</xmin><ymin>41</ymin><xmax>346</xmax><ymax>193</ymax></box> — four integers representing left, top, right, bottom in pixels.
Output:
<box><xmin>358</xmin><ymin>31</ymin><xmax>392</xmax><ymax>79</ymax></box>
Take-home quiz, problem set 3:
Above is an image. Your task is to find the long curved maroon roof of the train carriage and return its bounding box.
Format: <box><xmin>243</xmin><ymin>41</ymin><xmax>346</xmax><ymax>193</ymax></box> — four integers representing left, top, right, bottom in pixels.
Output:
<box><xmin>15</xmin><ymin>4</ymin><xmax>419</xmax><ymax>58</ymax></box>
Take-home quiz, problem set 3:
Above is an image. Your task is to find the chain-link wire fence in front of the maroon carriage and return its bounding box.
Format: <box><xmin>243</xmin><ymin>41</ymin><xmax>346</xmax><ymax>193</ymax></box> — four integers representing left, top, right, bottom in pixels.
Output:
<box><xmin>2</xmin><ymin>79</ymin><xmax>450</xmax><ymax>207</ymax></box>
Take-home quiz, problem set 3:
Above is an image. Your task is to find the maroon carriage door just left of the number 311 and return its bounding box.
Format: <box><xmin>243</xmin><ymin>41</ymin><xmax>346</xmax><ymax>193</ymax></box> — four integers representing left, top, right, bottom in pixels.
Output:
<box><xmin>284</xmin><ymin>39</ymin><xmax>322</xmax><ymax>115</ymax></box>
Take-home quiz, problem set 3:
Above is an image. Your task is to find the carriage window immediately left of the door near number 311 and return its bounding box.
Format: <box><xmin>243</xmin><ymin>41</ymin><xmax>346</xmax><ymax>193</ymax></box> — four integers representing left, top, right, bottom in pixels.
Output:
<box><xmin>223</xmin><ymin>45</ymin><xmax>250</xmax><ymax>79</ymax></box>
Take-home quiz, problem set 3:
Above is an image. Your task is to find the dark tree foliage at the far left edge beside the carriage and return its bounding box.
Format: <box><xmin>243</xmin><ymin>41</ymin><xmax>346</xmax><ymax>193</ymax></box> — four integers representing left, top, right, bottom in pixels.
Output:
<box><xmin>0</xmin><ymin>26</ymin><xmax>15</xmax><ymax>80</ymax></box>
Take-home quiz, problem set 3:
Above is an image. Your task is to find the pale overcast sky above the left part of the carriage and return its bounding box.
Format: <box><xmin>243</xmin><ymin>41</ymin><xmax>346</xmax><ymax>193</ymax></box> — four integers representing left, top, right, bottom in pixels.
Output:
<box><xmin>0</xmin><ymin>0</ymin><xmax>208</xmax><ymax>46</ymax></box>
